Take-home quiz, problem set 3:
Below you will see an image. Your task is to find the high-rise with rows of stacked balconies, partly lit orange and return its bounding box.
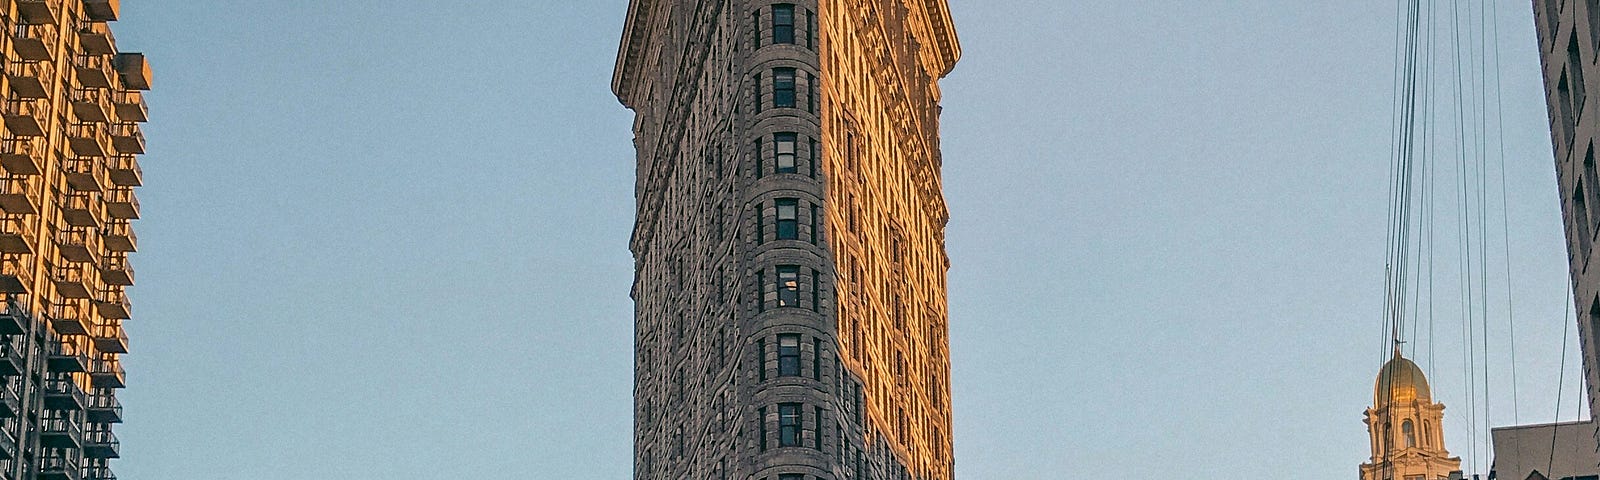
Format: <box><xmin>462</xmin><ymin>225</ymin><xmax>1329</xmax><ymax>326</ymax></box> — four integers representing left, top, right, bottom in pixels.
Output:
<box><xmin>0</xmin><ymin>0</ymin><xmax>150</xmax><ymax>480</ymax></box>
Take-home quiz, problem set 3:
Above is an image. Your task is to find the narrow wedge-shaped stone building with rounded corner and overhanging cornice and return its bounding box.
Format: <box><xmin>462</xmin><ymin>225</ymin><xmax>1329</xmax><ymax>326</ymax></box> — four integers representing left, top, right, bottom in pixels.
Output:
<box><xmin>613</xmin><ymin>0</ymin><xmax>960</xmax><ymax>480</ymax></box>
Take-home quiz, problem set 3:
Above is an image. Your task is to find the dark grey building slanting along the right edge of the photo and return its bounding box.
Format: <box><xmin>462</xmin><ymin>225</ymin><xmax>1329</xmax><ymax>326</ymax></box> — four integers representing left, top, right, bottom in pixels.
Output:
<box><xmin>1533</xmin><ymin>0</ymin><xmax>1600</xmax><ymax>451</ymax></box>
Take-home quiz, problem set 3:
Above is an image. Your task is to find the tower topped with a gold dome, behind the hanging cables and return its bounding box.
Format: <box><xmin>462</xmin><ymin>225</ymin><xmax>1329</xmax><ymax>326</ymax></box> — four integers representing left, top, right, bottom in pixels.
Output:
<box><xmin>1362</xmin><ymin>349</ymin><xmax>1461</xmax><ymax>480</ymax></box>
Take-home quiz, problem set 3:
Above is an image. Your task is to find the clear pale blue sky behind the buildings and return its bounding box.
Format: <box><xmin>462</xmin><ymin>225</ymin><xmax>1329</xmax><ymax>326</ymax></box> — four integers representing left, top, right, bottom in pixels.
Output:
<box><xmin>115</xmin><ymin>0</ymin><xmax>1579</xmax><ymax>480</ymax></box>
